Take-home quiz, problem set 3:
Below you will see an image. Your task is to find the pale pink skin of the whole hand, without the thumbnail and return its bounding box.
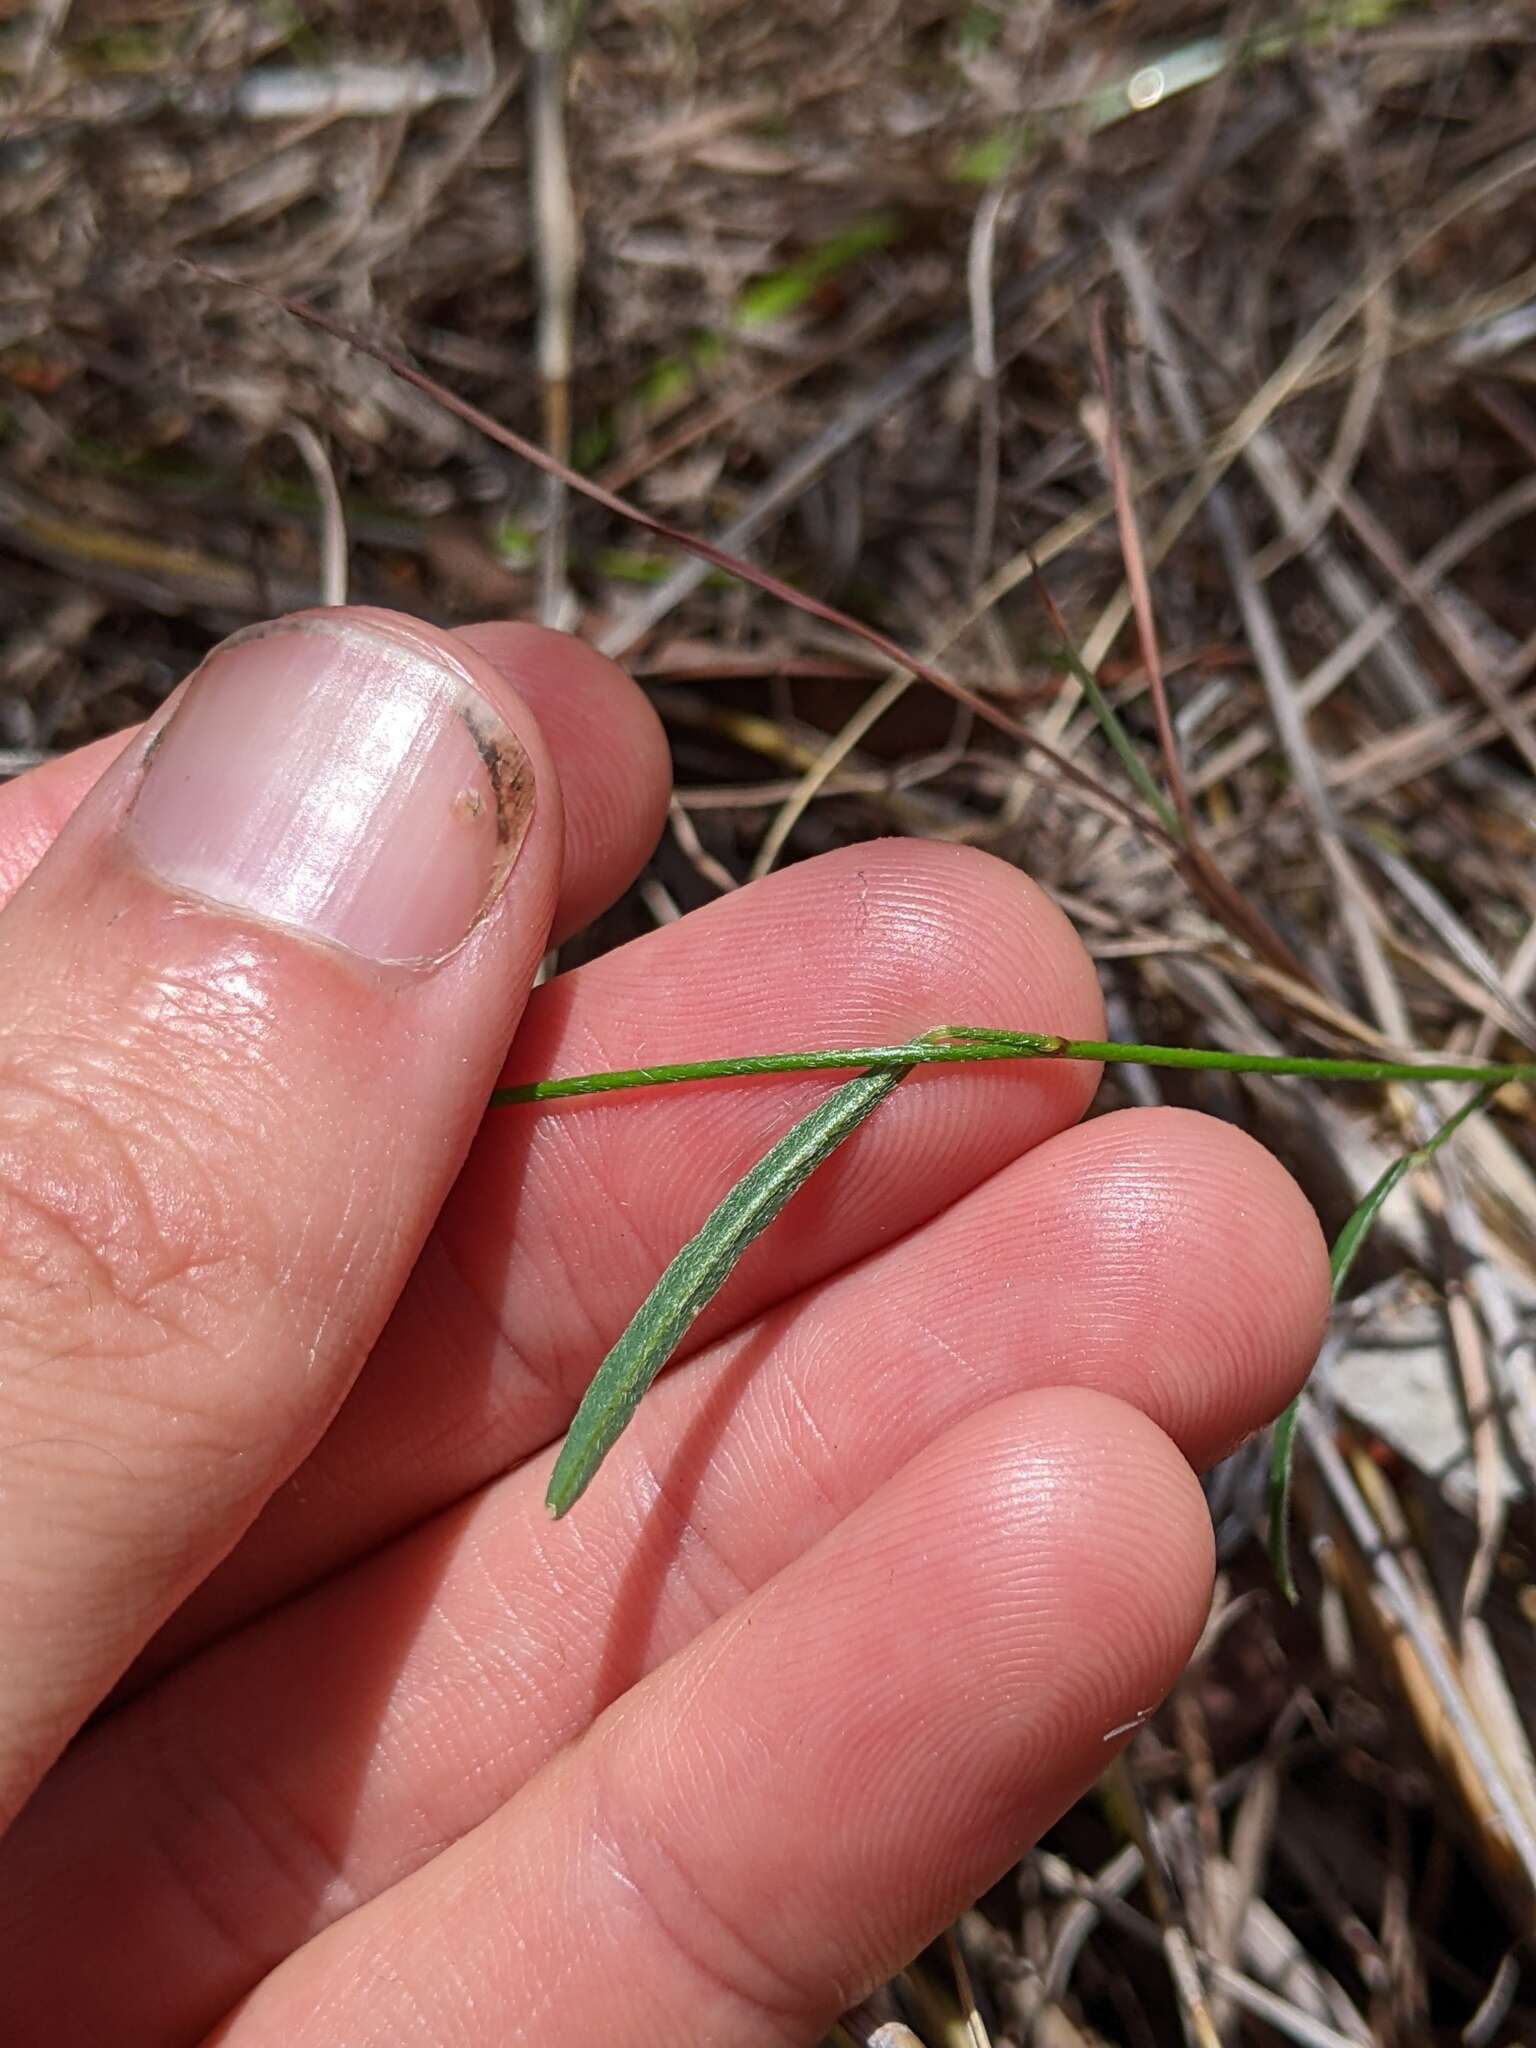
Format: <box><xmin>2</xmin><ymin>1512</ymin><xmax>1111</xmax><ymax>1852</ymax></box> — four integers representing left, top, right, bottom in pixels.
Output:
<box><xmin>0</xmin><ymin>625</ymin><xmax>1327</xmax><ymax>2048</ymax></box>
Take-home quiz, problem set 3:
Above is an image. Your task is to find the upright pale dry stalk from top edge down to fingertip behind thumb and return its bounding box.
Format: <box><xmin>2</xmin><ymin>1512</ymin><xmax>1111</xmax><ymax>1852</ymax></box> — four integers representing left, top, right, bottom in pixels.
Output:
<box><xmin>518</xmin><ymin>0</ymin><xmax>586</xmax><ymax>627</ymax></box>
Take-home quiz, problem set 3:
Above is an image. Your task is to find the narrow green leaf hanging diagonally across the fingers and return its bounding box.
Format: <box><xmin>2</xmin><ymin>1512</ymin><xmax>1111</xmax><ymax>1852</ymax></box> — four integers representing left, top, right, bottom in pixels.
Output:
<box><xmin>545</xmin><ymin>1067</ymin><xmax>911</xmax><ymax>1518</ymax></box>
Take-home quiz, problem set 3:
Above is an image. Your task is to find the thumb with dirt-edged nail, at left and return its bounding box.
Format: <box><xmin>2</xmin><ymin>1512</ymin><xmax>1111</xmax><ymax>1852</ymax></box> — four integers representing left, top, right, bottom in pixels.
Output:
<box><xmin>0</xmin><ymin>610</ymin><xmax>561</xmax><ymax>1827</ymax></box>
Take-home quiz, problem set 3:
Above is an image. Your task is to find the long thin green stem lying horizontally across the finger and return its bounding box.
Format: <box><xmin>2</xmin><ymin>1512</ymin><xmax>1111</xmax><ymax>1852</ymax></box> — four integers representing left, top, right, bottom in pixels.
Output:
<box><xmin>492</xmin><ymin>1024</ymin><xmax>1536</xmax><ymax>1108</ymax></box>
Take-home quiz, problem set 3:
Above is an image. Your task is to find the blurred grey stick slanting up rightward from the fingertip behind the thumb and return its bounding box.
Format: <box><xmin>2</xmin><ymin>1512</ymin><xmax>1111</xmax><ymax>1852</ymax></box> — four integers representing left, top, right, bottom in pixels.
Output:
<box><xmin>598</xmin><ymin>256</ymin><xmax>1069</xmax><ymax>659</ymax></box>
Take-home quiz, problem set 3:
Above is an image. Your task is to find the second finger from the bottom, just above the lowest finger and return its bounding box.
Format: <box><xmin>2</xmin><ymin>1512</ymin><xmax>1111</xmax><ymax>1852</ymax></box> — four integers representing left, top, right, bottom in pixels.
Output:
<box><xmin>0</xmin><ymin>1112</ymin><xmax>1327</xmax><ymax>2048</ymax></box>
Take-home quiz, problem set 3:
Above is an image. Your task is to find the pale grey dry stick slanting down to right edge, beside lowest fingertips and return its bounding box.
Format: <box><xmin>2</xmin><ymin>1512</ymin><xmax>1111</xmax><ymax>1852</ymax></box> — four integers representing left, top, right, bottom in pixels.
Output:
<box><xmin>1300</xmin><ymin>1395</ymin><xmax>1536</xmax><ymax>1890</ymax></box>
